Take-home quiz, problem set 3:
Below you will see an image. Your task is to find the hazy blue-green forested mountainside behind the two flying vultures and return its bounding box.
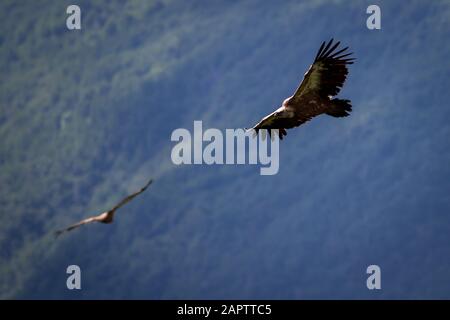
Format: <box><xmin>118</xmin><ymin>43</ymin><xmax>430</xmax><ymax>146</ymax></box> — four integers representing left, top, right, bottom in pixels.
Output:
<box><xmin>0</xmin><ymin>0</ymin><xmax>450</xmax><ymax>299</ymax></box>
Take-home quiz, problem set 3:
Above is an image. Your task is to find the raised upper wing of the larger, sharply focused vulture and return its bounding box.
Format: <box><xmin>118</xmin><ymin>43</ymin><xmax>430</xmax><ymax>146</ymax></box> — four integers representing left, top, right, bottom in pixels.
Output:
<box><xmin>291</xmin><ymin>39</ymin><xmax>355</xmax><ymax>107</ymax></box>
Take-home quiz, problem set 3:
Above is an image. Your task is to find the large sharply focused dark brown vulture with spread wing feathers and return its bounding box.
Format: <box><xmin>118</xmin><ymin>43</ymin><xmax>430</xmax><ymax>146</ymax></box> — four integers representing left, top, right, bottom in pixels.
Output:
<box><xmin>252</xmin><ymin>39</ymin><xmax>355</xmax><ymax>139</ymax></box>
